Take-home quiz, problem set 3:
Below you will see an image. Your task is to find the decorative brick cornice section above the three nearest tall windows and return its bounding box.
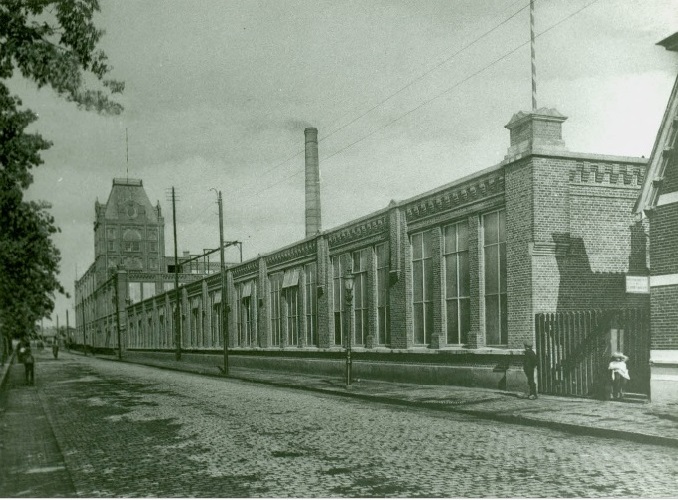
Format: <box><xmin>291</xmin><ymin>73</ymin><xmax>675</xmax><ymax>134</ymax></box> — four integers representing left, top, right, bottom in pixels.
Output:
<box><xmin>405</xmin><ymin>173</ymin><xmax>505</xmax><ymax>222</ymax></box>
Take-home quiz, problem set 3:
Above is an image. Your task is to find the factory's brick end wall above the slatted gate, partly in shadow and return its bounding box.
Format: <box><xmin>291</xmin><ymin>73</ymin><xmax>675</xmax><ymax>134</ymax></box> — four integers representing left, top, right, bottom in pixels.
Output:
<box><xmin>533</xmin><ymin>158</ymin><xmax>645</xmax><ymax>312</ymax></box>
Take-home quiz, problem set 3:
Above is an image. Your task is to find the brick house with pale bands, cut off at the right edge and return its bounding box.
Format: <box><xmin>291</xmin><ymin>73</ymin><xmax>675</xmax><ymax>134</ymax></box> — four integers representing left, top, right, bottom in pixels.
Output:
<box><xmin>635</xmin><ymin>33</ymin><xmax>678</xmax><ymax>401</ymax></box>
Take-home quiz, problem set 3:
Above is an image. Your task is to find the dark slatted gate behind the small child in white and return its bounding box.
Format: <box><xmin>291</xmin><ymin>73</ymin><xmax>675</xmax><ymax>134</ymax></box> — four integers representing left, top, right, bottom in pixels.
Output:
<box><xmin>535</xmin><ymin>309</ymin><xmax>650</xmax><ymax>398</ymax></box>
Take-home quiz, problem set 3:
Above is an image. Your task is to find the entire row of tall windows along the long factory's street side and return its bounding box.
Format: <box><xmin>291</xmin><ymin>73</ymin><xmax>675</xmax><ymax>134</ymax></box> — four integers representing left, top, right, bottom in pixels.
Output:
<box><xmin>130</xmin><ymin>210</ymin><xmax>508</xmax><ymax>346</ymax></box>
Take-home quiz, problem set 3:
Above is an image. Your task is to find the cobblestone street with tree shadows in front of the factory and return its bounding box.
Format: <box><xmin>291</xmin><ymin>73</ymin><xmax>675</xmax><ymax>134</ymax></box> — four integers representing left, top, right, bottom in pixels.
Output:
<box><xmin>1</xmin><ymin>353</ymin><xmax>678</xmax><ymax>497</ymax></box>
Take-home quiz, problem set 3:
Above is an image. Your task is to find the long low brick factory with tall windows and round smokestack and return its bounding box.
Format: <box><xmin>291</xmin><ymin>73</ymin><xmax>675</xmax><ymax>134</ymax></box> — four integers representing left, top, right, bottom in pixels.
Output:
<box><xmin>122</xmin><ymin>108</ymin><xmax>649</xmax><ymax>396</ymax></box>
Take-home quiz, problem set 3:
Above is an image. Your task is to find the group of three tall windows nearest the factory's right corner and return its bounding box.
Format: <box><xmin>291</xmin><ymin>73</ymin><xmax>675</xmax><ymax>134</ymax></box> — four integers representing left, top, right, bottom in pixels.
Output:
<box><xmin>411</xmin><ymin>210</ymin><xmax>508</xmax><ymax>346</ymax></box>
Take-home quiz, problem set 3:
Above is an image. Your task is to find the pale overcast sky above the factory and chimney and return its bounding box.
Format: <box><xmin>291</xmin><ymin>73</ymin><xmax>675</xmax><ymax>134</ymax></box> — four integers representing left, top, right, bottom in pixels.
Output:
<box><xmin>12</xmin><ymin>0</ymin><xmax>678</xmax><ymax>325</ymax></box>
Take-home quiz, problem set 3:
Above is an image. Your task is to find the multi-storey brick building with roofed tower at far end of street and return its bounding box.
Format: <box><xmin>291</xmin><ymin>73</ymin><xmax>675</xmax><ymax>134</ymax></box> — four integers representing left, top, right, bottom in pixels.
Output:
<box><xmin>74</xmin><ymin>179</ymin><xmax>219</xmax><ymax>349</ymax></box>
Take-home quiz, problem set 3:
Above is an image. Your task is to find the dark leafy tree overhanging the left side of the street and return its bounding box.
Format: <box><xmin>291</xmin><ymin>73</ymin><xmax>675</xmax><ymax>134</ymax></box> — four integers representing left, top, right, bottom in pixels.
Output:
<box><xmin>0</xmin><ymin>0</ymin><xmax>124</xmax><ymax>354</ymax></box>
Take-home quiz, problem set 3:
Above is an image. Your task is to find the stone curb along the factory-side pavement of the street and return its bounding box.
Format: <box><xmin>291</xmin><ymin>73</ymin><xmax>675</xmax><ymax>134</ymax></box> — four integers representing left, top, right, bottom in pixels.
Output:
<box><xmin>97</xmin><ymin>358</ymin><xmax>678</xmax><ymax>448</ymax></box>
